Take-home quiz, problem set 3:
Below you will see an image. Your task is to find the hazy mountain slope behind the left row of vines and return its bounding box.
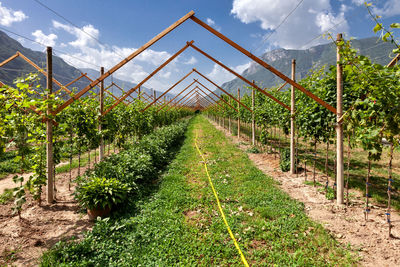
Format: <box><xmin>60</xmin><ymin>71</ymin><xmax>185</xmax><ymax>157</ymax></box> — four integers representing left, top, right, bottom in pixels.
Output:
<box><xmin>0</xmin><ymin>31</ymin><xmax>174</xmax><ymax>101</ymax></box>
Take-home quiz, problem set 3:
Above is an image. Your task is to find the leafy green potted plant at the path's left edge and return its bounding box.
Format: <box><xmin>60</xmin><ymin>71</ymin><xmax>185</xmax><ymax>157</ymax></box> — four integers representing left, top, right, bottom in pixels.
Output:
<box><xmin>75</xmin><ymin>177</ymin><xmax>131</xmax><ymax>220</ymax></box>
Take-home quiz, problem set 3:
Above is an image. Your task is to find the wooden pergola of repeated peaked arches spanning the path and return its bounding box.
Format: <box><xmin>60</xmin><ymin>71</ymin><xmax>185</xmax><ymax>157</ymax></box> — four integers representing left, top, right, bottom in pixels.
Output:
<box><xmin>0</xmin><ymin>11</ymin><xmax>344</xmax><ymax>204</ymax></box>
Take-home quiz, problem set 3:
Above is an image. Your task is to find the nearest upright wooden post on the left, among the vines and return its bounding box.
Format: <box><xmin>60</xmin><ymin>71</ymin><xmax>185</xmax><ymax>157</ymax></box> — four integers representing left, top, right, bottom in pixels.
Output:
<box><xmin>46</xmin><ymin>46</ymin><xmax>54</xmax><ymax>203</ymax></box>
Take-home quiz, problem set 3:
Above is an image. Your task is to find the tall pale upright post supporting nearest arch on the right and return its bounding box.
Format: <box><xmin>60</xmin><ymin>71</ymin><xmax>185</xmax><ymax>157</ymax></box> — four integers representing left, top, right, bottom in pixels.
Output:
<box><xmin>336</xmin><ymin>33</ymin><xmax>344</xmax><ymax>205</ymax></box>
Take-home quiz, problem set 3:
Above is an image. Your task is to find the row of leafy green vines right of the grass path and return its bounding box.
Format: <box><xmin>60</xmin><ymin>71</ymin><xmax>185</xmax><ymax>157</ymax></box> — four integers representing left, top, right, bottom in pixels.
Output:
<box><xmin>208</xmin><ymin>38</ymin><xmax>400</xmax><ymax>237</ymax></box>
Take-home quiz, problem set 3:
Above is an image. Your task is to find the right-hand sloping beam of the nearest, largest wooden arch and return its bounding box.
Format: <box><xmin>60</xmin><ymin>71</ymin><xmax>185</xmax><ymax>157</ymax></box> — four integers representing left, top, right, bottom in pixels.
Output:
<box><xmin>190</xmin><ymin>15</ymin><xmax>336</xmax><ymax>114</ymax></box>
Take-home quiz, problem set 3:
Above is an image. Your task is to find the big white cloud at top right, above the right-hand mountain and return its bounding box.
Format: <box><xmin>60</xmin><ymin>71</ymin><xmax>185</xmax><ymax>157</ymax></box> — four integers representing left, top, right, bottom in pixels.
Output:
<box><xmin>231</xmin><ymin>0</ymin><xmax>349</xmax><ymax>49</ymax></box>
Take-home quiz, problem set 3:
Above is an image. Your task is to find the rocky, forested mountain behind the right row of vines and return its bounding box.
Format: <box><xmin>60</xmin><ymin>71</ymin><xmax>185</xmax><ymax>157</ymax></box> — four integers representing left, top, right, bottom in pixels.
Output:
<box><xmin>222</xmin><ymin>37</ymin><xmax>394</xmax><ymax>94</ymax></box>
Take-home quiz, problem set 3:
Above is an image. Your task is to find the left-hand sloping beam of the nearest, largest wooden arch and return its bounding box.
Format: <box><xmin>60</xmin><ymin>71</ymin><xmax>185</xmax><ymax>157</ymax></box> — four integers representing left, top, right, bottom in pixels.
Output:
<box><xmin>55</xmin><ymin>11</ymin><xmax>194</xmax><ymax>114</ymax></box>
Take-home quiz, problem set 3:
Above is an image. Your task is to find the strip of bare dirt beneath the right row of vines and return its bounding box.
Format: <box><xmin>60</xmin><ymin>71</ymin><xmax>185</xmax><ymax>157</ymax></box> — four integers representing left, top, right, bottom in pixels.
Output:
<box><xmin>212</xmin><ymin>122</ymin><xmax>400</xmax><ymax>266</ymax></box>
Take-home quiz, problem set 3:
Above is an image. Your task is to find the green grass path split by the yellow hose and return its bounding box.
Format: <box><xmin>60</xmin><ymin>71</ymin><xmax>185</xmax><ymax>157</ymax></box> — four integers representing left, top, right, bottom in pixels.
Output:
<box><xmin>41</xmin><ymin>116</ymin><xmax>357</xmax><ymax>266</ymax></box>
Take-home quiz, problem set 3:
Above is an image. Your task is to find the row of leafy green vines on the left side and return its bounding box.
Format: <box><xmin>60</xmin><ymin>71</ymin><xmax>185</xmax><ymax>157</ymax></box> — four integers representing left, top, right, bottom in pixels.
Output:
<box><xmin>0</xmin><ymin>74</ymin><xmax>194</xmax><ymax>216</ymax></box>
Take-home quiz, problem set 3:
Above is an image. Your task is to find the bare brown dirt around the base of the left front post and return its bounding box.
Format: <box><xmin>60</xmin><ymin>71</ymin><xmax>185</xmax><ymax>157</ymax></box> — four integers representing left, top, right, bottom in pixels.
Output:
<box><xmin>0</xmin><ymin>167</ymin><xmax>92</xmax><ymax>266</ymax></box>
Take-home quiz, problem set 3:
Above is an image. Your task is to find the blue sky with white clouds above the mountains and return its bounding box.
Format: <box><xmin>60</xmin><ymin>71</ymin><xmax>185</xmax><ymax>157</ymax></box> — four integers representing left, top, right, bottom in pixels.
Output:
<box><xmin>0</xmin><ymin>0</ymin><xmax>400</xmax><ymax>94</ymax></box>
